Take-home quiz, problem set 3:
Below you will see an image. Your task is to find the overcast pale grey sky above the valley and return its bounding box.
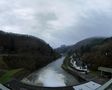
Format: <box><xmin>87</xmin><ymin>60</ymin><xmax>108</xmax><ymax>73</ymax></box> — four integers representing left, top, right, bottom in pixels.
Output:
<box><xmin>0</xmin><ymin>0</ymin><xmax>112</xmax><ymax>48</ymax></box>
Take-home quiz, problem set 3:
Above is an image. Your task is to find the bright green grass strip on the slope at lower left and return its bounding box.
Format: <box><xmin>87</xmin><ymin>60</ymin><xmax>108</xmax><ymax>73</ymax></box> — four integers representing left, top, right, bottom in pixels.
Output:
<box><xmin>0</xmin><ymin>69</ymin><xmax>23</xmax><ymax>84</ymax></box>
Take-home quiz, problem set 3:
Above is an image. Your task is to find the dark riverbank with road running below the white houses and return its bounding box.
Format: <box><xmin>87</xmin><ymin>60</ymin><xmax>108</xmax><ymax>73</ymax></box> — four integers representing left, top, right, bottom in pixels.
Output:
<box><xmin>62</xmin><ymin>57</ymin><xmax>109</xmax><ymax>85</ymax></box>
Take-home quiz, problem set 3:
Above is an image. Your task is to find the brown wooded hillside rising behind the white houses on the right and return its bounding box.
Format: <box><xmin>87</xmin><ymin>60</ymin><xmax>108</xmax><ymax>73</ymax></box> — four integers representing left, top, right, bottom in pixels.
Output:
<box><xmin>65</xmin><ymin>38</ymin><xmax>112</xmax><ymax>70</ymax></box>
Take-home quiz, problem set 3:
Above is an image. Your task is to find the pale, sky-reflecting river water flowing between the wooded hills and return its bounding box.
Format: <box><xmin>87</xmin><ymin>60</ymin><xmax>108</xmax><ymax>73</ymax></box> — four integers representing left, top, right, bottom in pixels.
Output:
<box><xmin>22</xmin><ymin>57</ymin><xmax>79</xmax><ymax>87</ymax></box>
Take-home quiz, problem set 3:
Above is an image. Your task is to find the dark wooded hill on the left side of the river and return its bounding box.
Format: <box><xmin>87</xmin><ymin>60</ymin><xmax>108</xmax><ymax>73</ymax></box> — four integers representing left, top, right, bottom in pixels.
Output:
<box><xmin>0</xmin><ymin>31</ymin><xmax>59</xmax><ymax>70</ymax></box>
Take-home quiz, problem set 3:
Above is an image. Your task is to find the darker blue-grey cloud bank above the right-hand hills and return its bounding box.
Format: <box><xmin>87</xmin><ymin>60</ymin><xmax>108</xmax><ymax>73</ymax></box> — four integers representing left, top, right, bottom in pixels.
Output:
<box><xmin>49</xmin><ymin>11</ymin><xmax>112</xmax><ymax>45</ymax></box>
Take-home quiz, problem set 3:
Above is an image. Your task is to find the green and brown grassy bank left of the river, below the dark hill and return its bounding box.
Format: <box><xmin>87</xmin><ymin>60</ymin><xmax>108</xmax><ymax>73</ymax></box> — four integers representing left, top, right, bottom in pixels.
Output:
<box><xmin>0</xmin><ymin>68</ymin><xmax>31</xmax><ymax>84</ymax></box>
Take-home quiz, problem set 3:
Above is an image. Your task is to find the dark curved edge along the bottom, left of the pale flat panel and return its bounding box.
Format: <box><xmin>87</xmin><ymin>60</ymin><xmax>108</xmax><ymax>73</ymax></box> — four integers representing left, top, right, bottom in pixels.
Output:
<box><xmin>5</xmin><ymin>79</ymin><xmax>74</xmax><ymax>90</ymax></box>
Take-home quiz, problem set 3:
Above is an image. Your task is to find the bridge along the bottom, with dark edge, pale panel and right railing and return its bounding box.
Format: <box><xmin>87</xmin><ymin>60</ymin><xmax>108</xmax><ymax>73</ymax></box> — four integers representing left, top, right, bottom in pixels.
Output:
<box><xmin>5</xmin><ymin>79</ymin><xmax>112</xmax><ymax>90</ymax></box>
